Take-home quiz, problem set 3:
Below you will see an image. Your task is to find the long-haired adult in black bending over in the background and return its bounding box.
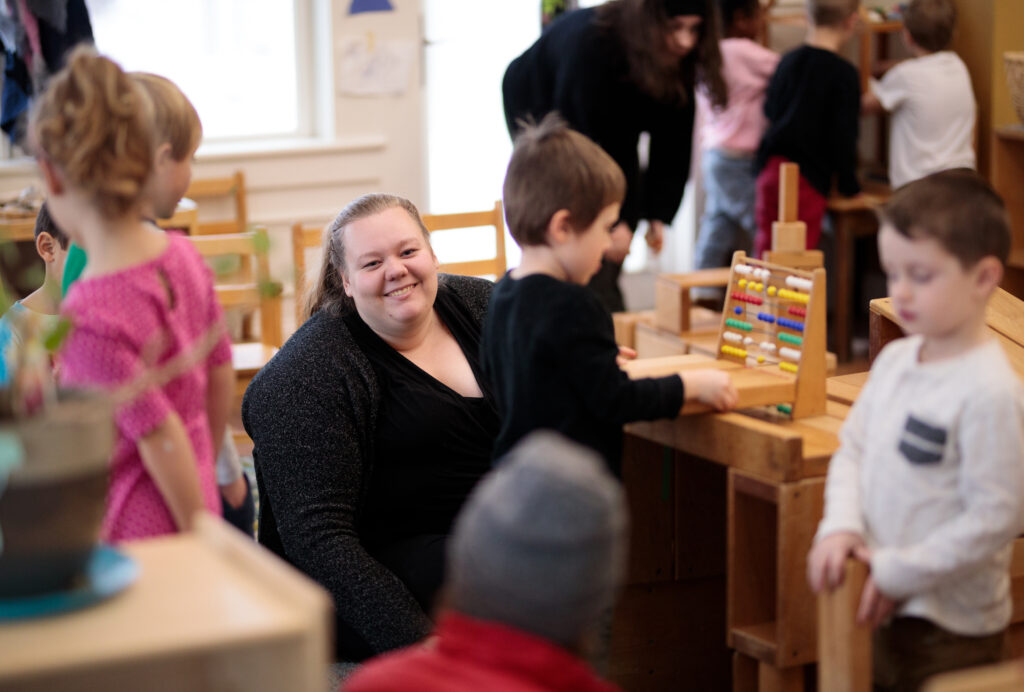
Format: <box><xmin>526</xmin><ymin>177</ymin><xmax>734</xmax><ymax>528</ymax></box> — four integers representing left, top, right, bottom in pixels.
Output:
<box><xmin>502</xmin><ymin>0</ymin><xmax>726</xmax><ymax>312</ymax></box>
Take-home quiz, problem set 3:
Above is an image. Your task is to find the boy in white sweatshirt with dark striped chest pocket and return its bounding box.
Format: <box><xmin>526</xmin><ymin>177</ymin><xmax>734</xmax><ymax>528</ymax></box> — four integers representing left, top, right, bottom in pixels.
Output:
<box><xmin>808</xmin><ymin>169</ymin><xmax>1024</xmax><ymax>690</ymax></box>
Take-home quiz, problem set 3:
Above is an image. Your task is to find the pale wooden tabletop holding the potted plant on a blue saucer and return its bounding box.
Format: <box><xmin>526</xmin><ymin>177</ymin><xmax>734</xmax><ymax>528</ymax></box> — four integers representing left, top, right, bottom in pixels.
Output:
<box><xmin>0</xmin><ymin>517</ymin><xmax>332</xmax><ymax>692</ymax></box>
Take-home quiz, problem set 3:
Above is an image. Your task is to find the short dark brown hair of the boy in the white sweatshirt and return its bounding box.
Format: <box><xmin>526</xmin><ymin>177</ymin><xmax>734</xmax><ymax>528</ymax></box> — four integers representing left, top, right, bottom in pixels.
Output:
<box><xmin>879</xmin><ymin>168</ymin><xmax>1010</xmax><ymax>269</ymax></box>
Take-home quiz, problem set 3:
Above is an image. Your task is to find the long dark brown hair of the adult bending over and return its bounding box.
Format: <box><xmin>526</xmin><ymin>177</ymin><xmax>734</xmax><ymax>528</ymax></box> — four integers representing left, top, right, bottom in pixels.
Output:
<box><xmin>596</xmin><ymin>0</ymin><xmax>728</xmax><ymax>107</ymax></box>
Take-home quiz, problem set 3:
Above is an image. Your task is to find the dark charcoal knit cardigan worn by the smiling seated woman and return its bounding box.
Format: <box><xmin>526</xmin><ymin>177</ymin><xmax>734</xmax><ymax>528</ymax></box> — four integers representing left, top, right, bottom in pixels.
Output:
<box><xmin>242</xmin><ymin>274</ymin><xmax>493</xmax><ymax>659</ymax></box>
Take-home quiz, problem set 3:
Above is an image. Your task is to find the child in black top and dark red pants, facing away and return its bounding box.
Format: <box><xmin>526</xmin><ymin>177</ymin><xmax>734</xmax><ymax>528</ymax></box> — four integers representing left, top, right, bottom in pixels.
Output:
<box><xmin>754</xmin><ymin>0</ymin><xmax>860</xmax><ymax>257</ymax></box>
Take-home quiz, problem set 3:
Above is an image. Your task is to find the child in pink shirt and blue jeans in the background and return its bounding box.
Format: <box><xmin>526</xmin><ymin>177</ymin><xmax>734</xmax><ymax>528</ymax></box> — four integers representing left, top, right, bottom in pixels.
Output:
<box><xmin>695</xmin><ymin>0</ymin><xmax>779</xmax><ymax>298</ymax></box>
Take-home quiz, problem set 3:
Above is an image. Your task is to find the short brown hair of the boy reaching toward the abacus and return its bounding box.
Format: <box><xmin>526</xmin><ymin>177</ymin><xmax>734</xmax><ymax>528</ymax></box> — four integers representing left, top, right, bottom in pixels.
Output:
<box><xmin>502</xmin><ymin>113</ymin><xmax>626</xmax><ymax>246</ymax></box>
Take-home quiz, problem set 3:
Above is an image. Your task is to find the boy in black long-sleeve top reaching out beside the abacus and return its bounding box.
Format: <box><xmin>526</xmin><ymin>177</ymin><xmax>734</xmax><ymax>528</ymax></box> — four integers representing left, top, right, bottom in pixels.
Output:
<box><xmin>480</xmin><ymin>115</ymin><xmax>736</xmax><ymax>473</ymax></box>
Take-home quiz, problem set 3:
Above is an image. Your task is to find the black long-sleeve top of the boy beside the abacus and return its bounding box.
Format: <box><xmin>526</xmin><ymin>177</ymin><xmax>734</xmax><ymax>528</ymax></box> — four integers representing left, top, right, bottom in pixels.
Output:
<box><xmin>480</xmin><ymin>274</ymin><xmax>683</xmax><ymax>473</ymax></box>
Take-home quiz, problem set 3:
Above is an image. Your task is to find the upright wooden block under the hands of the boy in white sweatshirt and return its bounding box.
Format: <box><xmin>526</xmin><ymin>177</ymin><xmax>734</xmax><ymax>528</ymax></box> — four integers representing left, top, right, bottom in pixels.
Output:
<box><xmin>817</xmin><ymin>560</ymin><xmax>871</xmax><ymax>692</ymax></box>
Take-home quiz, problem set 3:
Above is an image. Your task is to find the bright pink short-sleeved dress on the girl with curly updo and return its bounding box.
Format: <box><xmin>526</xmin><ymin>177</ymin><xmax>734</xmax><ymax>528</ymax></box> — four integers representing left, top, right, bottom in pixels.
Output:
<box><xmin>59</xmin><ymin>233</ymin><xmax>231</xmax><ymax>543</ymax></box>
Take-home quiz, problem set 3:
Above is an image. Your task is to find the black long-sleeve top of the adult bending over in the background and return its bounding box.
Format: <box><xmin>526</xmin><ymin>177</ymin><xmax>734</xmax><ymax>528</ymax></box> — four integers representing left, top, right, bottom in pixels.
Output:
<box><xmin>502</xmin><ymin>8</ymin><xmax>693</xmax><ymax>229</ymax></box>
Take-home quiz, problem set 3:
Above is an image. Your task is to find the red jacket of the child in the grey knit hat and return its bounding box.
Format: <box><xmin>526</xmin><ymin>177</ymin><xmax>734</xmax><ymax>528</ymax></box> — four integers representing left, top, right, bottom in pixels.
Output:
<box><xmin>342</xmin><ymin>612</ymin><xmax>620</xmax><ymax>692</ymax></box>
